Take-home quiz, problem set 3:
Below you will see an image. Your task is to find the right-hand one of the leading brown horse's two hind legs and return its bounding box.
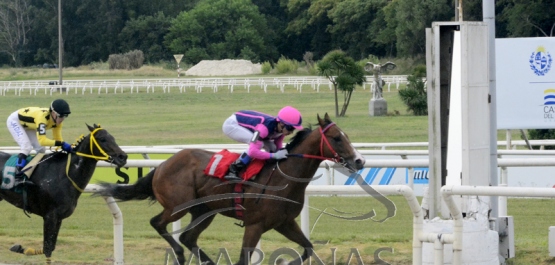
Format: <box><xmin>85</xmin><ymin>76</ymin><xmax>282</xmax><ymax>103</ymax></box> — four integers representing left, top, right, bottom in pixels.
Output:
<box><xmin>179</xmin><ymin>205</ymin><xmax>216</xmax><ymax>264</ymax></box>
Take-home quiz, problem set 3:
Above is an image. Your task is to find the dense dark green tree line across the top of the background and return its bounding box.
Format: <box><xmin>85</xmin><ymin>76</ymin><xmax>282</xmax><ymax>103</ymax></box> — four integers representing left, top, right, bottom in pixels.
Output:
<box><xmin>0</xmin><ymin>0</ymin><xmax>555</xmax><ymax>66</ymax></box>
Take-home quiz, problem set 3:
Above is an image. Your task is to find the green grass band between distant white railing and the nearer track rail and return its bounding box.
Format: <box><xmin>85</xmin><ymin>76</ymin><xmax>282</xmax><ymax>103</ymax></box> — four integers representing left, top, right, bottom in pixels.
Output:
<box><xmin>0</xmin><ymin>84</ymin><xmax>428</xmax><ymax>146</ymax></box>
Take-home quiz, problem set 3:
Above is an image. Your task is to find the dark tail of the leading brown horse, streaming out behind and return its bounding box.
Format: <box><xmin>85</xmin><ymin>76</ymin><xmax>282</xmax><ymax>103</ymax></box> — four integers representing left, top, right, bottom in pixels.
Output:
<box><xmin>95</xmin><ymin>169</ymin><xmax>156</xmax><ymax>201</ymax></box>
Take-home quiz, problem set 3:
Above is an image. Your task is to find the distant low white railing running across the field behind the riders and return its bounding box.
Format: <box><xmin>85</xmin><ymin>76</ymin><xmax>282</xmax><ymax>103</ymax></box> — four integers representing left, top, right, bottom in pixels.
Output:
<box><xmin>0</xmin><ymin>75</ymin><xmax>407</xmax><ymax>96</ymax></box>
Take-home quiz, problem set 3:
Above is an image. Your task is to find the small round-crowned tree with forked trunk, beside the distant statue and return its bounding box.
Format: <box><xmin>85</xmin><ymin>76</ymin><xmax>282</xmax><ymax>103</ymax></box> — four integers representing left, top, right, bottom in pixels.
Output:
<box><xmin>317</xmin><ymin>50</ymin><xmax>365</xmax><ymax>117</ymax></box>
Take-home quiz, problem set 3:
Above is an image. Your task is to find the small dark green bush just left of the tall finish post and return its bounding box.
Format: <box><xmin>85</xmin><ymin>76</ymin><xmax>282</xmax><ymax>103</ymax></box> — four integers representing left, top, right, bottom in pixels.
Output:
<box><xmin>399</xmin><ymin>65</ymin><xmax>428</xmax><ymax>116</ymax></box>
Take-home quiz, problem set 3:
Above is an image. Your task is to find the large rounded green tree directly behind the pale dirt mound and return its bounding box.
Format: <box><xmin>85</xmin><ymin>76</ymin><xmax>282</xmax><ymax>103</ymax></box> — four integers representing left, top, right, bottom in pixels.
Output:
<box><xmin>164</xmin><ymin>0</ymin><xmax>277</xmax><ymax>63</ymax></box>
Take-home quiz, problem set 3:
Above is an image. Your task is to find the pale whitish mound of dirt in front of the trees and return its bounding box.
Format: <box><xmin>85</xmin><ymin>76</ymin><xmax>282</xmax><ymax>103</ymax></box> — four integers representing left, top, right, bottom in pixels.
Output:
<box><xmin>185</xmin><ymin>59</ymin><xmax>262</xmax><ymax>76</ymax></box>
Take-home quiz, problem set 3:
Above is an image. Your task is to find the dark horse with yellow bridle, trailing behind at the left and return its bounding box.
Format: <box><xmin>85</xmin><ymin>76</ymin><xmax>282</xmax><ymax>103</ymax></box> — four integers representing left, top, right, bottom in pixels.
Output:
<box><xmin>0</xmin><ymin>122</ymin><xmax>127</xmax><ymax>264</ymax></box>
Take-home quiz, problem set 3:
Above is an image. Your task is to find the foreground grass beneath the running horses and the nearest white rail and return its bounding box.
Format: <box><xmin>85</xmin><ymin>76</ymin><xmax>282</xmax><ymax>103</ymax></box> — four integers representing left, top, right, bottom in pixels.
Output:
<box><xmin>0</xmin><ymin>195</ymin><xmax>555</xmax><ymax>265</ymax></box>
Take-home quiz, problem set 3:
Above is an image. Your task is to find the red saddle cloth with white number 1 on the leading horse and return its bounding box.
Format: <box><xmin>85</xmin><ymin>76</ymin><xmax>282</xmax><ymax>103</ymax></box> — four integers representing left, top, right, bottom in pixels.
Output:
<box><xmin>204</xmin><ymin>149</ymin><xmax>265</xmax><ymax>181</ymax></box>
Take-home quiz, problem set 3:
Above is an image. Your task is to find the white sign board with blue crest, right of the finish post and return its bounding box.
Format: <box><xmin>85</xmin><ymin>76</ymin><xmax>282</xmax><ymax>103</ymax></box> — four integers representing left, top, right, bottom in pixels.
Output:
<box><xmin>495</xmin><ymin>38</ymin><xmax>555</xmax><ymax>129</ymax></box>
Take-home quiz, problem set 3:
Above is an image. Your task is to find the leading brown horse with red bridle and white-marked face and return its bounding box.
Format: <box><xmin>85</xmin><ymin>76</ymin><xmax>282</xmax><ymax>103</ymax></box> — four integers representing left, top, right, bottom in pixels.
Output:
<box><xmin>98</xmin><ymin>113</ymin><xmax>365</xmax><ymax>264</ymax></box>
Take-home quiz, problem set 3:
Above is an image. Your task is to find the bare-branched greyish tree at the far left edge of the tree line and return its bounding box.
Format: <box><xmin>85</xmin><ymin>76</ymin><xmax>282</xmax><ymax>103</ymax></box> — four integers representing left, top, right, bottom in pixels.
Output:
<box><xmin>0</xmin><ymin>0</ymin><xmax>32</xmax><ymax>66</ymax></box>
